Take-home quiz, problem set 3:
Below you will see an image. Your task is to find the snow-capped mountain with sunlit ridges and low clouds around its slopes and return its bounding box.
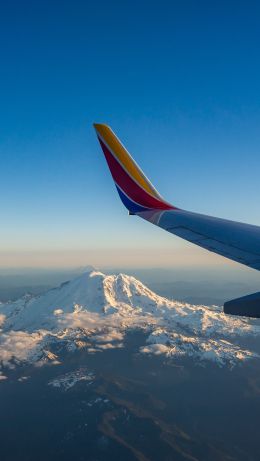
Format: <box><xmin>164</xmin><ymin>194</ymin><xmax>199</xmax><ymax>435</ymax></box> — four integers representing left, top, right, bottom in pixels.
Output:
<box><xmin>0</xmin><ymin>271</ymin><xmax>260</xmax><ymax>379</ymax></box>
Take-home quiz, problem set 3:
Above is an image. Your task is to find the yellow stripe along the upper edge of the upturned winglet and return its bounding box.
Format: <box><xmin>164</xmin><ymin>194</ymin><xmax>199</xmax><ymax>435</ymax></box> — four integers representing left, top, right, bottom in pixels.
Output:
<box><xmin>94</xmin><ymin>123</ymin><xmax>161</xmax><ymax>200</ymax></box>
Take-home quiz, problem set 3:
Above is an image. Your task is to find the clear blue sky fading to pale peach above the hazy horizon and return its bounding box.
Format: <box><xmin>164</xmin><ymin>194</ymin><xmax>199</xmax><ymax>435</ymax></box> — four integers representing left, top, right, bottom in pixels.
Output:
<box><xmin>0</xmin><ymin>0</ymin><xmax>260</xmax><ymax>266</ymax></box>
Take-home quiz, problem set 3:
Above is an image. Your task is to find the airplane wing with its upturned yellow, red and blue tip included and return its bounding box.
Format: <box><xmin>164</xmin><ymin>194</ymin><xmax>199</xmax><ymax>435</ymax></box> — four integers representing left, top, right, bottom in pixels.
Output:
<box><xmin>94</xmin><ymin>124</ymin><xmax>260</xmax><ymax>316</ymax></box>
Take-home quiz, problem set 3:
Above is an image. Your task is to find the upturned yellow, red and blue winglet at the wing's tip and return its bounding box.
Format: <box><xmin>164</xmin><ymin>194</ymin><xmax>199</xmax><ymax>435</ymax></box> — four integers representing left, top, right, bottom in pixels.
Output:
<box><xmin>94</xmin><ymin>123</ymin><xmax>175</xmax><ymax>214</ymax></box>
